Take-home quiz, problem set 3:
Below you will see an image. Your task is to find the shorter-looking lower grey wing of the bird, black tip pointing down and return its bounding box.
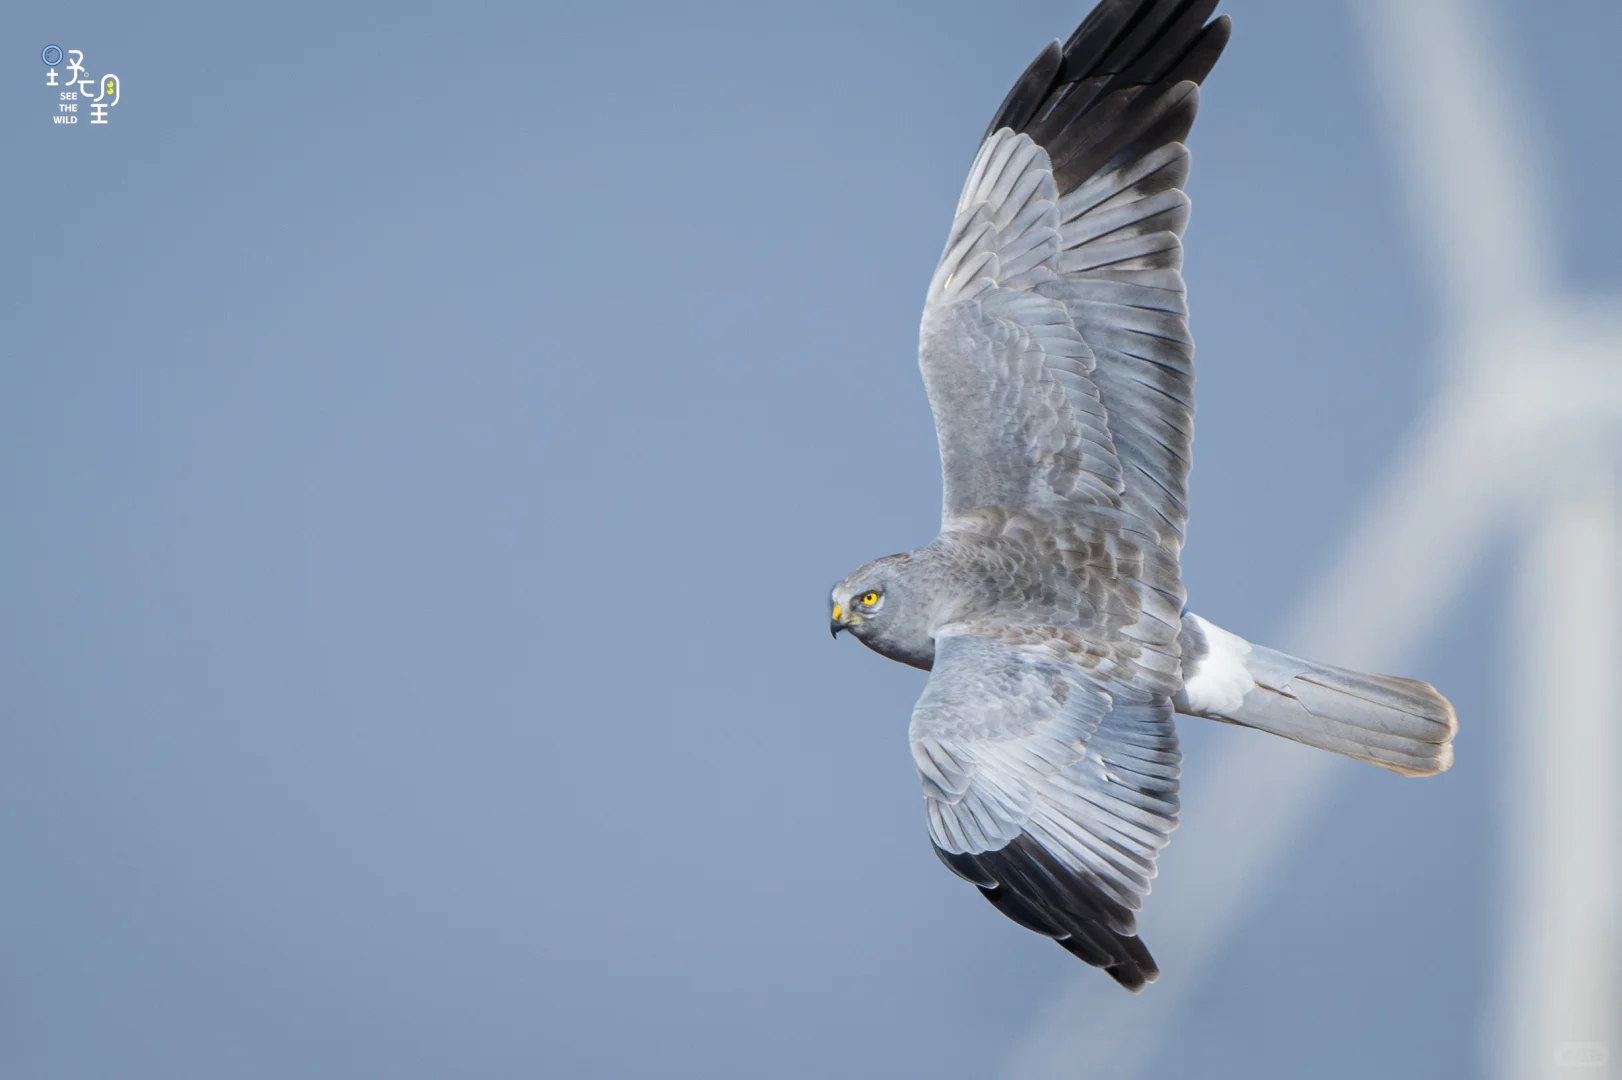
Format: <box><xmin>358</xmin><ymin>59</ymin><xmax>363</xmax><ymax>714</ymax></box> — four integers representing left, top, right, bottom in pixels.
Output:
<box><xmin>912</xmin><ymin>631</ymin><xmax>1181</xmax><ymax>991</ymax></box>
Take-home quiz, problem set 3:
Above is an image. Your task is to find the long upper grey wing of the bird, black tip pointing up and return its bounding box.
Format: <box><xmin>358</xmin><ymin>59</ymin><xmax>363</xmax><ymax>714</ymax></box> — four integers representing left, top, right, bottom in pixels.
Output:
<box><xmin>920</xmin><ymin>0</ymin><xmax>1228</xmax><ymax>553</ymax></box>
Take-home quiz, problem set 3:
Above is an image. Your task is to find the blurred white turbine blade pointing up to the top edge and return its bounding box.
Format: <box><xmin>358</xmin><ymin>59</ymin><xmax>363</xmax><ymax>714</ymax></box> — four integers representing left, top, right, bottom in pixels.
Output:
<box><xmin>1353</xmin><ymin>0</ymin><xmax>1552</xmax><ymax>326</ymax></box>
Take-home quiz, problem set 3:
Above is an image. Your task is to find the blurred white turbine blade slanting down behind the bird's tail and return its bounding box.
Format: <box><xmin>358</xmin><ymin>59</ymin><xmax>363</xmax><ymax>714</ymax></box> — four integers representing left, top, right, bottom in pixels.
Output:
<box><xmin>1002</xmin><ymin>391</ymin><xmax>1521</xmax><ymax>1080</ymax></box>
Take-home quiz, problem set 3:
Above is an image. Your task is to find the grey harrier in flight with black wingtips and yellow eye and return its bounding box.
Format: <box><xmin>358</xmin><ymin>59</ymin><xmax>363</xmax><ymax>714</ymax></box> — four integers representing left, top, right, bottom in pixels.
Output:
<box><xmin>832</xmin><ymin>0</ymin><xmax>1457</xmax><ymax>991</ymax></box>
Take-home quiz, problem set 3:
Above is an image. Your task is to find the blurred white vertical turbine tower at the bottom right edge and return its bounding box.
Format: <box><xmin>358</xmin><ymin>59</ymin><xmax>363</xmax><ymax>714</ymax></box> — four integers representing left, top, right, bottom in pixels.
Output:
<box><xmin>1486</xmin><ymin>457</ymin><xmax>1622</xmax><ymax>1080</ymax></box>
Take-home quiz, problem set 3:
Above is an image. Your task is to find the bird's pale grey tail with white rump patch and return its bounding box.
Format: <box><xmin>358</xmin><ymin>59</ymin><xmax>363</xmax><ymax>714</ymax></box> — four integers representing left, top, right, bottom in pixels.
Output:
<box><xmin>1176</xmin><ymin>615</ymin><xmax>1458</xmax><ymax>777</ymax></box>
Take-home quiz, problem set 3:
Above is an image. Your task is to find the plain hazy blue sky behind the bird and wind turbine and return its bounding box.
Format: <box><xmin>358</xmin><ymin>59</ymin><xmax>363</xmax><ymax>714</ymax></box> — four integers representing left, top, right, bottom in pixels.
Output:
<box><xmin>0</xmin><ymin>0</ymin><xmax>1622</xmax><ymax>1080</ymax></box>
